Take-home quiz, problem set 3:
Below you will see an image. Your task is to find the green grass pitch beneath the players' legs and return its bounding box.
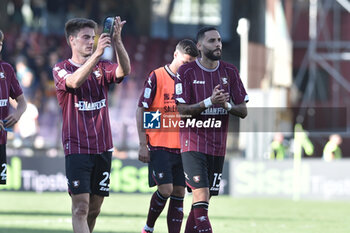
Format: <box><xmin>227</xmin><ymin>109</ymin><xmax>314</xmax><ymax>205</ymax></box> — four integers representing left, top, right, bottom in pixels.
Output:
<box><xmin>0</xmin><ymin>191</ymin><xmax>350</xmax><ymax>233</ymax></box>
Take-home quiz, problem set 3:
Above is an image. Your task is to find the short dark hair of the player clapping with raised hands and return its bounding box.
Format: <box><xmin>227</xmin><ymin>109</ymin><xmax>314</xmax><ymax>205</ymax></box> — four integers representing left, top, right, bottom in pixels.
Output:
<box><xmin>64</xmin><ymin>18</ymin><xmax>97</xmax><ymax>45</ymax></box>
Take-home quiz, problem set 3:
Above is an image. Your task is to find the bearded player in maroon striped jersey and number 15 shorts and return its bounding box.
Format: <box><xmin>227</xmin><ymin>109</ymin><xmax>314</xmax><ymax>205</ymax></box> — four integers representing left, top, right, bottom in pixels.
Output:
<box><xmin>175</xmin><ymin>27</ymin><xmax>248</xmax><ymax>233</ymax></box>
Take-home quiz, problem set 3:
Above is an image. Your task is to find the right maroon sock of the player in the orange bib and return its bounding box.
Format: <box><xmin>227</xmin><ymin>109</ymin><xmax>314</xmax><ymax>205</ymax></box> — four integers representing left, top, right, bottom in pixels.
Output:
<box><xmin>167</xmin><ymin>196</ymin><xmax>184</xmax><ymax>233</ymax></box>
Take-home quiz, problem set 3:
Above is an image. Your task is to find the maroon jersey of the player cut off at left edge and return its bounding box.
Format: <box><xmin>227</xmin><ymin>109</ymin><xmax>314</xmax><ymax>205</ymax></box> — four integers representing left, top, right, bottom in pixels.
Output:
<box><xmin>0</xmin><ymin>61</ymin><xmax>23</xmax><ymax>144</ymax></box>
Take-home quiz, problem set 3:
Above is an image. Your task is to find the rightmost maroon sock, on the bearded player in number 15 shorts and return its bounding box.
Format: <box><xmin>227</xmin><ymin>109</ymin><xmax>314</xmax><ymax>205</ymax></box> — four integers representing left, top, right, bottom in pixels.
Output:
<box><xmin>192</xmin><ymin>201</ymin><xmax>213</xmax><ymax>233</ymax></box>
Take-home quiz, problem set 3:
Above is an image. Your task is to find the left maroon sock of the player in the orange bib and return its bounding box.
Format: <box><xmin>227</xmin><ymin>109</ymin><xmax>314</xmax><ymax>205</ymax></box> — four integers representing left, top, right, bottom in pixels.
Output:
<box><xmin>147</xmin><ymin>190</ymin><xmax>167</xmax><ymax>228</ymax></box>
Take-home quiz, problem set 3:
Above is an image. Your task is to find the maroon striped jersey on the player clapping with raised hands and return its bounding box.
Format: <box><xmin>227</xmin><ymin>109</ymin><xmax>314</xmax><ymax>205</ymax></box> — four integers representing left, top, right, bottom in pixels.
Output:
<box><xmin>53</xmin><ymin>59</ymin><xmax>122</xmax><ymax>155</ymax></box>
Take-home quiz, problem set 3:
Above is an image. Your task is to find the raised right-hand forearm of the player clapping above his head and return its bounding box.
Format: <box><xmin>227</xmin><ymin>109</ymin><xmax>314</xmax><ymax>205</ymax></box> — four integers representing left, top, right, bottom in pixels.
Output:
<box><xmin>114</xmin><ymin>41</ymin><xmax>130</xmax><ymax>78</ymax></box>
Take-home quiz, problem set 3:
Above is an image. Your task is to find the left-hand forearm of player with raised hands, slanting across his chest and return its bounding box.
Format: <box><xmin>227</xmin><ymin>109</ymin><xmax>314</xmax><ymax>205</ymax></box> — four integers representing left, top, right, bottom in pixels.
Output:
<box><xmin>66</xmin><ymin>52</ymin><xmax>101</xmax><ymax>89</ymax></box>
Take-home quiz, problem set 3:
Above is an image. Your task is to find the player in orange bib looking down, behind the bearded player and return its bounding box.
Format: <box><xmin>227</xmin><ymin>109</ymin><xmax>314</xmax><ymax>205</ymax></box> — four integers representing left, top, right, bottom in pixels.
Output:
<box><xmin>136</xmin><ymin>39</ymin><xmax>198</xmax><ymax>233</ymax></box>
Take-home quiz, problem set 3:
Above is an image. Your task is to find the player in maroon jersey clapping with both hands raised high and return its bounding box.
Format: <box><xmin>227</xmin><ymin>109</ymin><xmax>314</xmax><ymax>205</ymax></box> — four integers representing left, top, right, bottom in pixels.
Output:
<box><xmin>53</xmin><ymin>16</ymin><xmax>130</xmax><ymax>233</ymax></box>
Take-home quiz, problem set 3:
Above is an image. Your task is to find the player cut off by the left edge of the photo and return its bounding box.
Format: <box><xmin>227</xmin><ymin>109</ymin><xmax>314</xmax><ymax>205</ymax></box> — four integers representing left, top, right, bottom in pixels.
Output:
<box><xmin>0</xmin><ymin>30</ymin><xmax>27</xmax><ymax>185</ymax></box>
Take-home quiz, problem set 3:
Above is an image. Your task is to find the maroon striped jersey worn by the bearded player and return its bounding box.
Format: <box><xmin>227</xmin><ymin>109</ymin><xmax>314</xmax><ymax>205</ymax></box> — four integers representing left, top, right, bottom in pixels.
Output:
<box><xmin>175</xmin><ymin>59</ymin><xmax>249</xmax><ymax>156</ymax></box>
